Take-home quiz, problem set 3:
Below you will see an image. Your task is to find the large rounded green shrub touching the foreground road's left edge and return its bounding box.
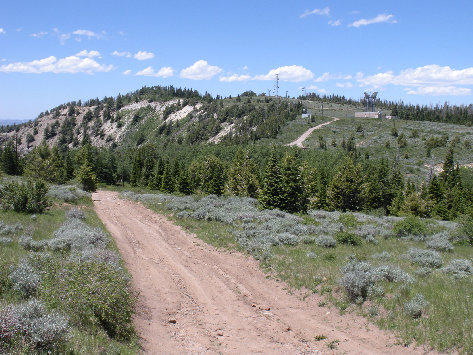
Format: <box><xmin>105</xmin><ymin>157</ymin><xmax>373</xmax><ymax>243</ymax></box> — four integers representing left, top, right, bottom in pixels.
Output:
<box><xmin>41</xmin><ymin>262</ymin><xmax>133</xmax><ymax>340</ymax></box>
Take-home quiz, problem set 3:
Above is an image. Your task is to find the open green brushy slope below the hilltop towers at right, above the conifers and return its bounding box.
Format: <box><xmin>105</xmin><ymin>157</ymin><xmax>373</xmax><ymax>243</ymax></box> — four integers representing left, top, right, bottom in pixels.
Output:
<box><xmin>272</xmin><ymin>111</ymin><xmax>473</xmax><ymax>181</ymax></box>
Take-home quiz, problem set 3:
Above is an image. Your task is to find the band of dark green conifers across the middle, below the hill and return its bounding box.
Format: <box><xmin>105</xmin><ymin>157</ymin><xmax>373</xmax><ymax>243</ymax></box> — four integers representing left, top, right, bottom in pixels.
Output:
<box><xmin>0</xmin><ymin>142</ymin><xmax>473</xmax><ymax>220</ymax></box>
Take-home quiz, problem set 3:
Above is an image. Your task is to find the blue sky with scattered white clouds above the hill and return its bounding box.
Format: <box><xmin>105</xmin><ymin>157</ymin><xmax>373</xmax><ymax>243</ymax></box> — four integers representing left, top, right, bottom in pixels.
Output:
<box><xmin>0</xmin><ymin>0</ymin><xmax>473</xmax><ymax>119</ymax></box>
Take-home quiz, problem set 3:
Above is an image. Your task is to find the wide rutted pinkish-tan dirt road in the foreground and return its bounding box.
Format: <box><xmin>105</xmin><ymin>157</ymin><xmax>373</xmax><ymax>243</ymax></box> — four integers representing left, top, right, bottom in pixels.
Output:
<box><xmin>93</xmin><ymin>191</ymin><xmax>421</xmax><ymax>354</ymax></box>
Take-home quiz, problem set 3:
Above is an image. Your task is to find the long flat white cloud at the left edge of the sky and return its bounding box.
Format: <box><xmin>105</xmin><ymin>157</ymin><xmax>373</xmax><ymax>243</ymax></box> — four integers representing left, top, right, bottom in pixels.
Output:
<box><xmin>0</xmin><ymin>56</ymin><xmax>114</xmax><ymax>74</ymax></box>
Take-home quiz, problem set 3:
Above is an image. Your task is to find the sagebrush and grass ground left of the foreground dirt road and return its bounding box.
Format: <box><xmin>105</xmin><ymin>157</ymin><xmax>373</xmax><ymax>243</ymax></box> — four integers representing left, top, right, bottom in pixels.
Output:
<box><xmin>0</xmin><ymin>178</ymin><xmax>139</xmax><ymax>354</ymax></box>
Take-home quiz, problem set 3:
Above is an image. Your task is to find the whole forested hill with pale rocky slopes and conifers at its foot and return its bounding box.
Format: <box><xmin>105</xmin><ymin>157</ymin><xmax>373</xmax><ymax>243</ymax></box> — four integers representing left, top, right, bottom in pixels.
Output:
<box><xmin>0</xmin><ymin>86</ymin><xmax>473</xmax><ymax>219</ymax></box>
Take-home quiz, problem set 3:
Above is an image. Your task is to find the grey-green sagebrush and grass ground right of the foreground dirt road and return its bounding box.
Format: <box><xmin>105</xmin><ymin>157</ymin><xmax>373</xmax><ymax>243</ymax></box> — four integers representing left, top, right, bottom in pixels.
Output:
<box><xmin>122</xmin><ymin>191</ymin><xmax>473</xmax><ymax>353</ymax></box>
